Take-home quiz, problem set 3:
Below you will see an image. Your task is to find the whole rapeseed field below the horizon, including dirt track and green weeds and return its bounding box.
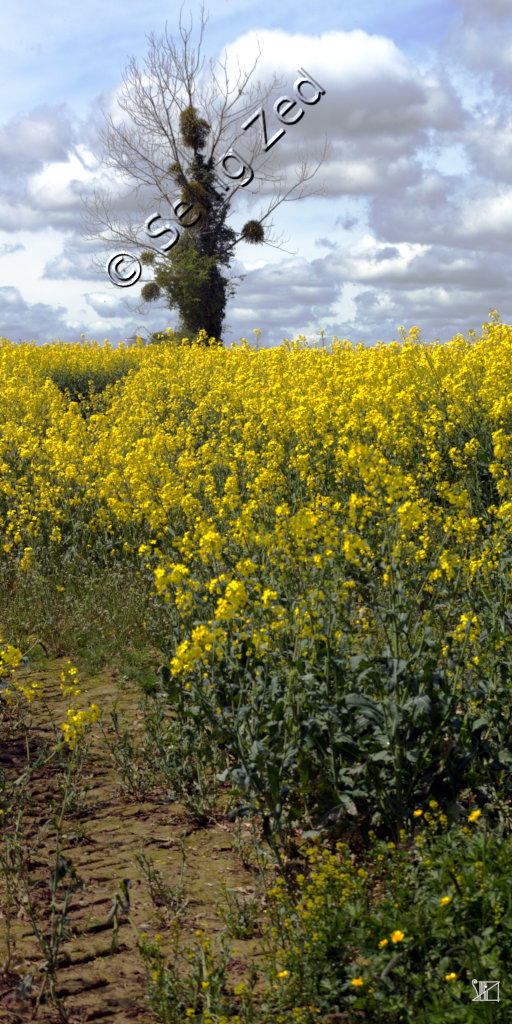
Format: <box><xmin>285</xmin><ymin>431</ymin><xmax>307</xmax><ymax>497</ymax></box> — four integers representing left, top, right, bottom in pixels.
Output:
<box><xmin>0</xmin><ymin>312</ymin><xmax>512</xmax><ymax>1024</ymax></box>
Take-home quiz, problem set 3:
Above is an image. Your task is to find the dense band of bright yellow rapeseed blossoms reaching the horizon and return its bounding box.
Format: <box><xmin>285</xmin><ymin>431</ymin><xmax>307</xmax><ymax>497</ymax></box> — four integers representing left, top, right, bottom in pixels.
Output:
<box><xmin>0</xmin><ymin>314</ymin><xmax>512</xmax><ymax>676</ymax></box>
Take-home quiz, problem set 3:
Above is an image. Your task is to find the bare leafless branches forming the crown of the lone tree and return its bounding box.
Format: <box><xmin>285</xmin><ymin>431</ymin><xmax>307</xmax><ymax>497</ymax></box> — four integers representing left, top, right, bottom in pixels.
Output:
<box><xmin>81</xmin><ymin>4</ymin><xmax>327</xmax><ymax>307</ymax></box>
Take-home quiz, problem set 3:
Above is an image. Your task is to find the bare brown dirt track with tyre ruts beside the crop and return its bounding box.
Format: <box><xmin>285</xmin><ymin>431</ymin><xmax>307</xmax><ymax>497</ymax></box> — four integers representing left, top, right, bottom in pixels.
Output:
<box><xmin>0</xmin><ymin>658</ymin><xmax>262</xmax><ymax>1024</ymax></box>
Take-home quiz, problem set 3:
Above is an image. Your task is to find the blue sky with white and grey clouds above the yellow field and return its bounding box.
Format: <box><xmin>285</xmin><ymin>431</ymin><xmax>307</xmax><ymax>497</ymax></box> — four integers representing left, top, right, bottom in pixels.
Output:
<box><xmin>0</xmin><ymin>0</ymin><xmax>512</xmax><ymax>346</ymax></box>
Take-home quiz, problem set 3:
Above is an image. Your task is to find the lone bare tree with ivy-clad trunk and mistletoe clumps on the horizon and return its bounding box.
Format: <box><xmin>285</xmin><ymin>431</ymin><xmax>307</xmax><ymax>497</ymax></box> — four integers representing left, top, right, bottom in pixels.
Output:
<box><xmin>81</xmin><ymin>1</ymin><xmax>327</xmax><ymax>344</ymax></box>
